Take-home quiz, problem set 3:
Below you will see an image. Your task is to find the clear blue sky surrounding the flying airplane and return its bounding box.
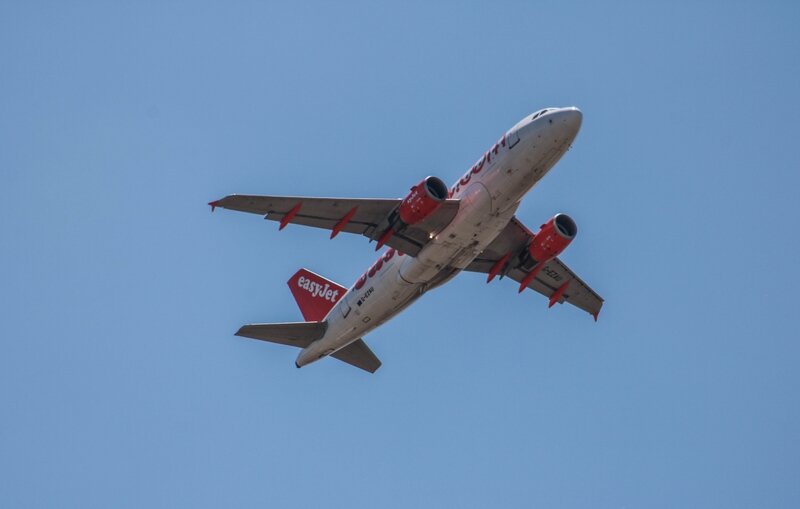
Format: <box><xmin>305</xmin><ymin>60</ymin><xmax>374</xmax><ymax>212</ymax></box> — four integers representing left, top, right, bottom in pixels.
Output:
<box><xmin>0</xmin><ymin>0</ymin><xmax>800</xmax><ymax>508</ymax></box>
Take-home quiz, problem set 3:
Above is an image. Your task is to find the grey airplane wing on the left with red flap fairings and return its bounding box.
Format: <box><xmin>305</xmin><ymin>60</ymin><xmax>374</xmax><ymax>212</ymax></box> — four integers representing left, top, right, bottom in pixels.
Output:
<box><xmin>209</xmin><ymin>194</ymin><xmax>459</xmax><ymax>256</ymax></box>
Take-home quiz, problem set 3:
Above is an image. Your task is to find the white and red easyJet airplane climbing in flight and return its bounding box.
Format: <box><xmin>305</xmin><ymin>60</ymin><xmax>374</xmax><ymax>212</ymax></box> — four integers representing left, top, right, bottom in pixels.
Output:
<box><xmin>209</xmin><ymin>107</ymin><xmax>603</xmax><ymax>373</ymax></box>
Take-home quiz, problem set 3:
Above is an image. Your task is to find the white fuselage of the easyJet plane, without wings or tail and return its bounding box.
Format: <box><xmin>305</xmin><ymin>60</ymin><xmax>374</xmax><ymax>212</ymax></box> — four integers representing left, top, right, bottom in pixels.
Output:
<box><xmin>296</xmin><ymin>108</ymin><xmax>582</xmax><ymax>367</ymax></box>
